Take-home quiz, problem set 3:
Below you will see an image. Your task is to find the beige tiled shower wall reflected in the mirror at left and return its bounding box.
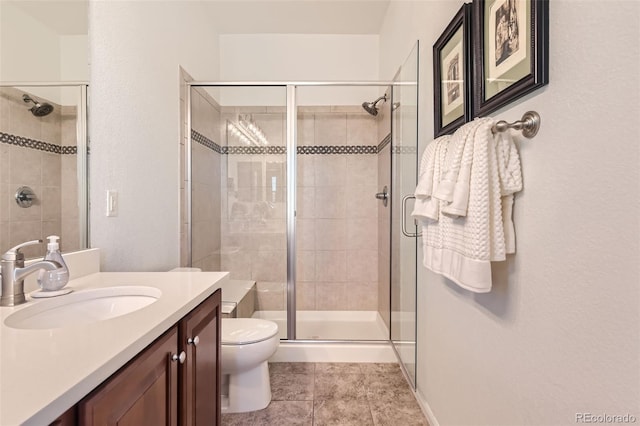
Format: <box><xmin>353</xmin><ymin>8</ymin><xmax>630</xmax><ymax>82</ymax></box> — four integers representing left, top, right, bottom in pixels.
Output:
<box><xmin>0</xmin><ymin>88</ymin><xmax>80</xmax><ymax>257</ymax></box>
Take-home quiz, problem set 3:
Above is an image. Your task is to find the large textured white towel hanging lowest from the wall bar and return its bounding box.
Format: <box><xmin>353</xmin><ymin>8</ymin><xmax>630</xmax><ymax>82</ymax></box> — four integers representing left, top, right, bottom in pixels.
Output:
<box><xmin>421</xmin><ymin>118</ymin><xmax>517</xmax><ymax>293</ymax></box>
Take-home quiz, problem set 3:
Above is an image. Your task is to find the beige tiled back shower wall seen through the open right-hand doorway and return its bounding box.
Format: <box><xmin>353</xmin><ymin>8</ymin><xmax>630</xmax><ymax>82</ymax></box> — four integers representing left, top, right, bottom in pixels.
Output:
<box><xmin>296</xmin><ymin>106</ymin><xmax>378</xmax><ymax>311</ymax></box>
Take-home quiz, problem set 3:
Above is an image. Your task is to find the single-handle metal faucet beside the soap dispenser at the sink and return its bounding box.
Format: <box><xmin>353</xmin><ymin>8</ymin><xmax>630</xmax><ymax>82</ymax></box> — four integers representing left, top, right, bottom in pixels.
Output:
<box><xmin>0</xmin><ymin>240</ymin><xmax>62</xmax><ymax>306</ymax></box>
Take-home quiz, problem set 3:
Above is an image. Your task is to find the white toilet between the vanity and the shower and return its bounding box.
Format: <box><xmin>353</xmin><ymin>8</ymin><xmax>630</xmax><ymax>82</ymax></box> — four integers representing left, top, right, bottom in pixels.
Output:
<box><xmin>221</xmin><ymin>318</ymin><xmax>280</xmax><ymax>413</ymax></box>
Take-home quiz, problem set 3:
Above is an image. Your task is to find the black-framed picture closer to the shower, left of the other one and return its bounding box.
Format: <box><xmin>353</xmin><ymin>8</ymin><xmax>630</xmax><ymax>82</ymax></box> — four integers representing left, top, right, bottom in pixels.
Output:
<box><xmin>433</xmin><ymin>4</ymin><xmax>471</xmax><ymax>137</ymax></box>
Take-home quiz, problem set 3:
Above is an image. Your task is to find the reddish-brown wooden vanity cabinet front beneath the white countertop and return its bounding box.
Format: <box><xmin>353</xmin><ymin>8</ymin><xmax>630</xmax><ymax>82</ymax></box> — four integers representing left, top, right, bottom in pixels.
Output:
<box><xmin>73</xmin><ymin>290</ymin><xmax>221</xmax><ymax>426</ymax></box>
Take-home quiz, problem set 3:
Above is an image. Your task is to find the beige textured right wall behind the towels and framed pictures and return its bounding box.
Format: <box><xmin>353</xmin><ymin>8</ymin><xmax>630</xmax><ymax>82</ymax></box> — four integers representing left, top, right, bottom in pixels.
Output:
<box><xmin>380</xmin><ymin>1</ymin><xmax>640</xmax><ymax>425</ymax></box>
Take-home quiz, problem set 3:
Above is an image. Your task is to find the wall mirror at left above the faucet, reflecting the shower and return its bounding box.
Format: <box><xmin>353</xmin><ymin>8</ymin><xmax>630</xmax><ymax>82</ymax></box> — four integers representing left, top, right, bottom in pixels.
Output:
<box><xmin>0</xmin><ymin>0</ymin><xmax>89</xmax><ymax>258</ymax></box>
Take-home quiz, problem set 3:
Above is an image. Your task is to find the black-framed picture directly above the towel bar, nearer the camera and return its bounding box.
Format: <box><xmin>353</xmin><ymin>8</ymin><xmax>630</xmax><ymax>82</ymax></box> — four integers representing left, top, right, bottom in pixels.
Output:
<box><xmin>472</xmin><ymin>0</ymin><xmax>549</xmax><ymax>117</ymax></box>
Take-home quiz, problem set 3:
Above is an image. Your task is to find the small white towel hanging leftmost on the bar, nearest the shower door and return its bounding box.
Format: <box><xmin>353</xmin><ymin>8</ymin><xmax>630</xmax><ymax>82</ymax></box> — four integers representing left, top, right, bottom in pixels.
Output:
<box><xmin>411</xmin><ymin>135</ymin><xmax>450</xmax><ymax>220</ymax></box>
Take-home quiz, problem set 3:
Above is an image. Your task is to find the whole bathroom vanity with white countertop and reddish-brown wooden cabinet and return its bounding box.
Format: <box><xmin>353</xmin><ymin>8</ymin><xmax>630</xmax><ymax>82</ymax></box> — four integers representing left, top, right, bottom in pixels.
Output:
<box><xmin>0</xmin><ymin>255</ymin><xmax>228</xmax><ymax>425</ymax></box>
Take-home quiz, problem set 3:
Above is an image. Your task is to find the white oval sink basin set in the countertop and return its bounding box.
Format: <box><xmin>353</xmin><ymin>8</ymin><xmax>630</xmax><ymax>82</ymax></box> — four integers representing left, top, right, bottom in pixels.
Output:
<box><xmin>4</xmin><ymin>286</ymin><xmax>162</xmax><ymax>330</ymax></box>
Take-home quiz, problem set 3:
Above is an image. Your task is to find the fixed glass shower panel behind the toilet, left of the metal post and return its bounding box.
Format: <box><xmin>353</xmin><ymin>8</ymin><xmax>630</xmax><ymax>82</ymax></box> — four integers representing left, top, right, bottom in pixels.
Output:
<box><xmin>190</xmin><ymin>85</ymin><xmax>287</xmax><ymax>339</ymax></box>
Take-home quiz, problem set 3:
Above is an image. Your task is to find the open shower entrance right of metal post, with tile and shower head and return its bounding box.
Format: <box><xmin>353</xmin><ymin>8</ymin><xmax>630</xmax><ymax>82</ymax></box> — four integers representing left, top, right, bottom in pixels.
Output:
<box><xmin>290</xmin><ymin>82</ymin><xmax>391</xmax><ymax>341</ymax></box>
